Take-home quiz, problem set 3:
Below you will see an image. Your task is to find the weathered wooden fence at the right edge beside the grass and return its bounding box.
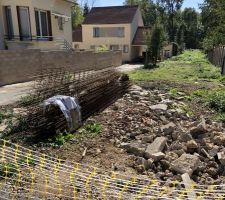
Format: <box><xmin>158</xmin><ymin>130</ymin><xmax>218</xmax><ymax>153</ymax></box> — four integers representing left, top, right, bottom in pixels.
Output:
<box><xmin>208</xmin><ymin>46</ymin><xmax>225</xmax><ymax>75</ymax></box>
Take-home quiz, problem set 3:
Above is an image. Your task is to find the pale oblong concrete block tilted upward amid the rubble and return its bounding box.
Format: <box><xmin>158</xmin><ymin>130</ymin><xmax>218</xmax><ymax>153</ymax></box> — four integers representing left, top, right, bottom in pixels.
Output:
<box><xmin>145</xmin><ymin>137</ymin><xmax>167</xmax><ymax>158</ymax></box>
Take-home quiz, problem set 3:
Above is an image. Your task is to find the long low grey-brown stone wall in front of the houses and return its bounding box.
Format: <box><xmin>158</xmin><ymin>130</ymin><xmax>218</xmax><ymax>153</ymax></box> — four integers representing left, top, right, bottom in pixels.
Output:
<box><xmin>0</xmin><ymin>50</ymin><xmax>122</xmax><ymax>86</ymax></box>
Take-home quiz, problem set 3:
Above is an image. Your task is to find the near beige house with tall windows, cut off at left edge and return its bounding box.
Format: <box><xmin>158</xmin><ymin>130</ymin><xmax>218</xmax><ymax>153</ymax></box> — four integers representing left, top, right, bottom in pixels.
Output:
<box><xmin>0</xmin><ymin>0</ymin><xmax>74</xmax><ymax>50</ymax></box>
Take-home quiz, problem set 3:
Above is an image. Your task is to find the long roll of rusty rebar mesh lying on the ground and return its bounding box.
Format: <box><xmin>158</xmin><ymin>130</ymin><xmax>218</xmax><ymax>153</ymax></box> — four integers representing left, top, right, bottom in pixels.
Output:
<box><xmin>20</xmin><ymin>69</ymin><xmax>130</xmax><ymax>134</ymax></box>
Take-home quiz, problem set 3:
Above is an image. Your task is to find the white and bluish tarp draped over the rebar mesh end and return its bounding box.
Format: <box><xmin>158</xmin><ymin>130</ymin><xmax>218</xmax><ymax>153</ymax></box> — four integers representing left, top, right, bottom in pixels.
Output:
<box><xmin>44</xmin><ymin>95</ymin><xmax>81</xmax><ymax>131</ymax></box>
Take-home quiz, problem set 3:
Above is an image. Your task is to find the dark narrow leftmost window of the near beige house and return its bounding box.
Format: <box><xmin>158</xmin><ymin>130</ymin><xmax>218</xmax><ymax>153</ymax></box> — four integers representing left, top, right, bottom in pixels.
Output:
<box><xmin>4</xmin><ymin>6</ymin><xmax>14</xmax><ymax>40</ymax></box>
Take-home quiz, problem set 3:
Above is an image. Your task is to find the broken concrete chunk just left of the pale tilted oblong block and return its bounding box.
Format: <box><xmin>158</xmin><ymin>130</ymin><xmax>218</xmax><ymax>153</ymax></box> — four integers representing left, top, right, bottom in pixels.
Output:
<box><xmin>120</xmin><ymin>142</ymin><xmax>146</xmax><ymax>157</ymax></box>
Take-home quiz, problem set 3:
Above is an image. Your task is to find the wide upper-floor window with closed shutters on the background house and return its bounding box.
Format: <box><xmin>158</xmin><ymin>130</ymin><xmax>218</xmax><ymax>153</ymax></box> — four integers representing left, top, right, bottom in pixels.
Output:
<box><xmin>93</xmin><ymin>27</ymin><xmax>125</xmax><ymax>37</ymax></box>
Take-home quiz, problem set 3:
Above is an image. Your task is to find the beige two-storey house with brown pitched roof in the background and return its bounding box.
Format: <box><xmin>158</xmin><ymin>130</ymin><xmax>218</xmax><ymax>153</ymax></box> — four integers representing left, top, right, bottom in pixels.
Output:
<box><xmin>73</xmin><ymin>6</ymin><xmax>146</xmax><ymax>61</ymax></box>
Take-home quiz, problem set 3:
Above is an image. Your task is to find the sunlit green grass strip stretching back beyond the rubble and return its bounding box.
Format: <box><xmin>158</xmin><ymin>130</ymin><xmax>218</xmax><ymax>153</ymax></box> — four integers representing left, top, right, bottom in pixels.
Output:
<box><xmin>129</xmin><ymin>50</ymin><xmax>221</xmax><ymax>82</ymax></box>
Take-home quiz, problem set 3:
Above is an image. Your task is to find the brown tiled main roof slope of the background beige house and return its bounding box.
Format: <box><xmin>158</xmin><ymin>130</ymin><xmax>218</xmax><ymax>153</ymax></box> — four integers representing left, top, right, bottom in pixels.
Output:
<box><xmin>83</xmin><ymin>6</ymin><xmax>138</xmax><ymax>24</ymax></box>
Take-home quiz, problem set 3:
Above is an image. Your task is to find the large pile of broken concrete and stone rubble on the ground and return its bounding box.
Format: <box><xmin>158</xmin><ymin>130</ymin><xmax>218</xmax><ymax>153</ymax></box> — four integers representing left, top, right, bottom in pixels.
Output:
<box><xmin>102</xmin><ymin>86</ymin><xmax>225</xmax><ymax>185</ymax></box>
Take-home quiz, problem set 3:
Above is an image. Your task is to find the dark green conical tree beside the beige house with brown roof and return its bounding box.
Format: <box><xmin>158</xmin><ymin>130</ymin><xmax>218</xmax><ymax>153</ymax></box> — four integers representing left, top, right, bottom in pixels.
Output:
<box><xmin>145</xmin><ymin>21</ymin><xmax>166</xmax><ymax>67</ymax></box>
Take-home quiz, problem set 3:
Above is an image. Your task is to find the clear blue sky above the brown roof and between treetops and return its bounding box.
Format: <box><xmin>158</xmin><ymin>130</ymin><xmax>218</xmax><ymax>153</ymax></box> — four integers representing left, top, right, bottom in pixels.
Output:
<box><xmin>79</xmin><ymin>0</ymin><xmax>203</xmax><ymax>9</ymax></box>
